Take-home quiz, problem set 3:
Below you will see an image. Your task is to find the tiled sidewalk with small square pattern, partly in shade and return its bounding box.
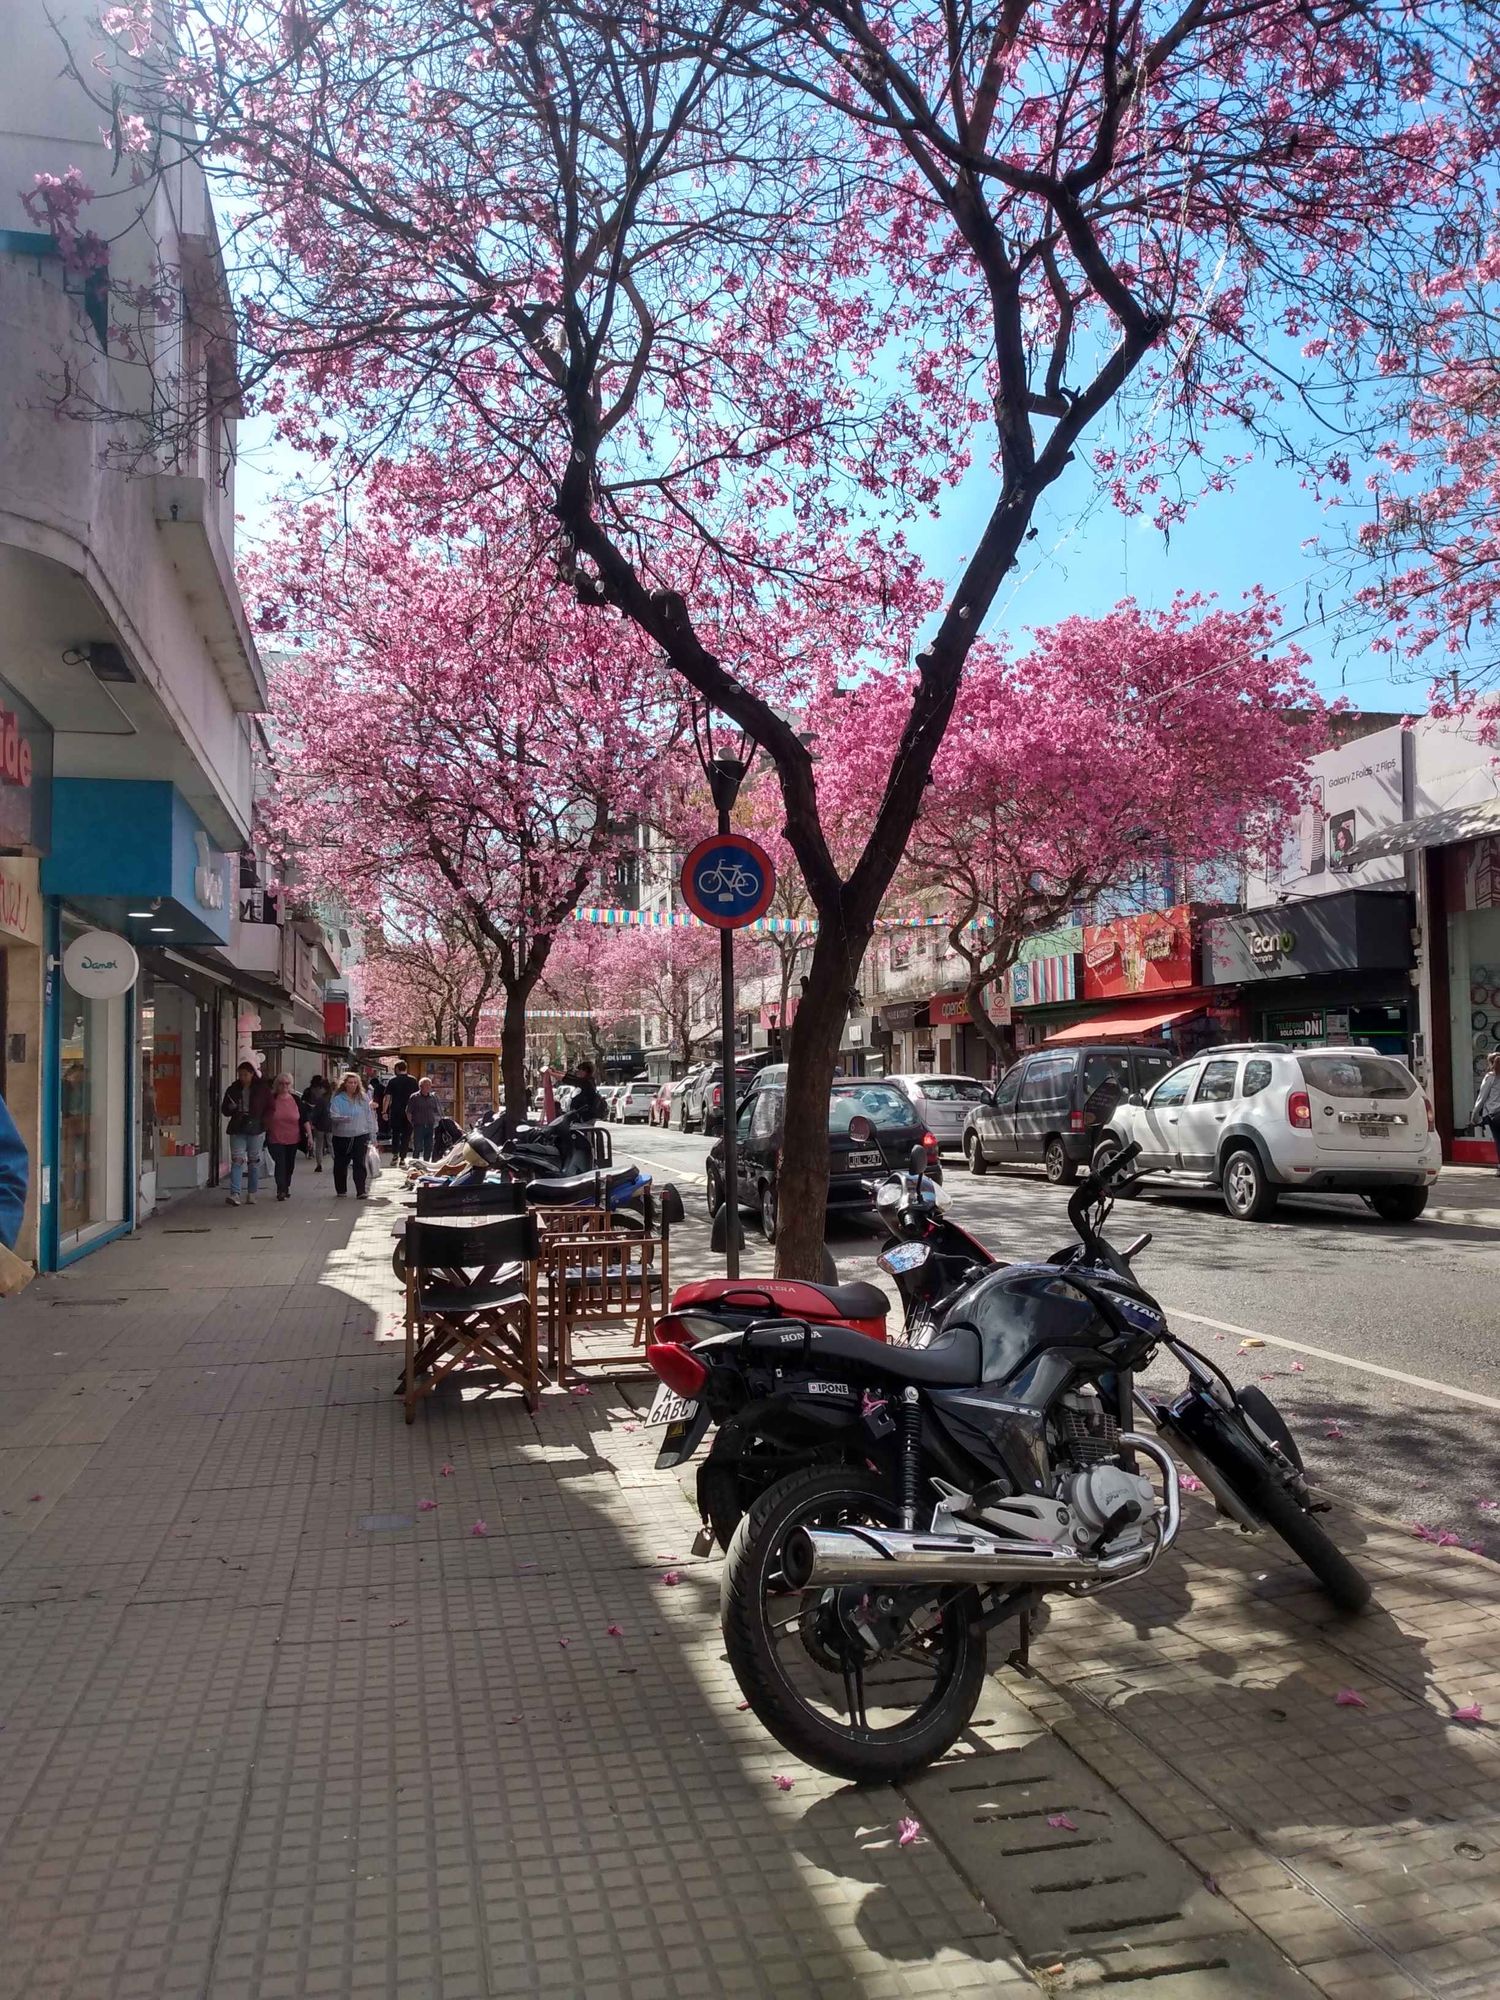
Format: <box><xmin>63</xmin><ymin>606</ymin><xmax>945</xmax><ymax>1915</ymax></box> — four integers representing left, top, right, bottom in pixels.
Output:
<box><xmin>0</xmin><ymin>1178</ymin><xmax>1500</xmax><ymax>2000</ymax></box>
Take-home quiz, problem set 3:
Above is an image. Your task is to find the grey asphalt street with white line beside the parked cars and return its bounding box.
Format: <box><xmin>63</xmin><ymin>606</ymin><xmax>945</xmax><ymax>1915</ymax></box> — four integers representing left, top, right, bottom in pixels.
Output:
<box><xmin>614</xmin><ymin>1126</ymin><xmax>1500</xmax><ymax>1560</ymax></box>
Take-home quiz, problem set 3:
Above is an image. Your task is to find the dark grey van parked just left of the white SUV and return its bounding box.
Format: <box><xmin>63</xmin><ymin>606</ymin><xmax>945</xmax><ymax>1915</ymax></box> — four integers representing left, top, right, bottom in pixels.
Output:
<box><xmin>964</xmin><ymin>1042</ymin><xmax>1174</xmax><ymax>1186</ymax></box>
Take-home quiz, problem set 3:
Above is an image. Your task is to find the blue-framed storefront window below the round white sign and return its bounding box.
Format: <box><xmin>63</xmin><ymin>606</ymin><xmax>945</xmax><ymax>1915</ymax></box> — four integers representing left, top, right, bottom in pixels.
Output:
<box><xmin>58</xmin><ymin>920</ymin><xmax>130</xmax><ymax>1254</ymax></box>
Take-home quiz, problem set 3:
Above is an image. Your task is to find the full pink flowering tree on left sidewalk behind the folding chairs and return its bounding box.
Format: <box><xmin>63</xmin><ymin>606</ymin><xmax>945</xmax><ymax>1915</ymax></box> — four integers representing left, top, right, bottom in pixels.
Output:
<box><xmin>258</xmin><ymin>488</ymin><xmax>676</xmax><ymax>1106</ymax></box>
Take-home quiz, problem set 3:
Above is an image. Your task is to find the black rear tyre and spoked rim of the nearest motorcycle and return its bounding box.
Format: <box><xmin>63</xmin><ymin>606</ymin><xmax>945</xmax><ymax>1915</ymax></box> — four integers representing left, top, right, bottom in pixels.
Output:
<box><xmin>720</xmin><ymin>1468</ymin><xmax>988</xmax><ymax>1784</ymax></box>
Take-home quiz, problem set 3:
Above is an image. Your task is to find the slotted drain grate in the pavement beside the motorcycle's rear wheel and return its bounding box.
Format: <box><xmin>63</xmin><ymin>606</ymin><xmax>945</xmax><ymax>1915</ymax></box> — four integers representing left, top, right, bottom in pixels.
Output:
<box><xmin>906</xmin><ymin>1684</ymin><xmax>1314</xmax><ymax>2000</ymax></box>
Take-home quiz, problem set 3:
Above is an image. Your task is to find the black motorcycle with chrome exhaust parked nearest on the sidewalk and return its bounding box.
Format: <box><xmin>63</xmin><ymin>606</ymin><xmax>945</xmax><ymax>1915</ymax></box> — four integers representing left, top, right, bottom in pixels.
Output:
<box><xmin>648</xmin><ymin>1148</ymin><xmax>1370</xmax><ymax>1784</ymax></box>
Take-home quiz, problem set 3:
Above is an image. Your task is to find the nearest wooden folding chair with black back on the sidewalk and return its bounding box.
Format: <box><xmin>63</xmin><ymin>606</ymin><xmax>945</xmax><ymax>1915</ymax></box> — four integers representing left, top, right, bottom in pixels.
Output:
<box><xmin>402</xmin><ymin>1216</ymin><xmax>542</xmax><ymax>1424</ymax></box>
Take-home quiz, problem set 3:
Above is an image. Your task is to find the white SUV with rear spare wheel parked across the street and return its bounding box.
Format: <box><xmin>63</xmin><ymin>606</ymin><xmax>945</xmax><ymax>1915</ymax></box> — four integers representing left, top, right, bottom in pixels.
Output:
<box><xmin>1094</xmin><ymin>1044</ymin><xmax>1442</xmax><ymax>1222</ymax></box>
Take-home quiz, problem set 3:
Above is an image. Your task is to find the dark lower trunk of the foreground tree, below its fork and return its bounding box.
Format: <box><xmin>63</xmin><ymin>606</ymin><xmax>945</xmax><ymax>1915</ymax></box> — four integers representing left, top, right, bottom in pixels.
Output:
<box><xmin>776</xmin><ymin>918</ymin><xmax>874</xmax><ymax>1280</ymax></box>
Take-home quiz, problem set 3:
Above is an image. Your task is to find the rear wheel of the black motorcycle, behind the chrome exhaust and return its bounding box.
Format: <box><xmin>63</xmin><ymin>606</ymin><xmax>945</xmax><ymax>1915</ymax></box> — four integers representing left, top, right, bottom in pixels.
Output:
<box><xmin>720</xmin><ymin>1468</ymin><xmax>986</xmax><ymax>1784</ymax></box>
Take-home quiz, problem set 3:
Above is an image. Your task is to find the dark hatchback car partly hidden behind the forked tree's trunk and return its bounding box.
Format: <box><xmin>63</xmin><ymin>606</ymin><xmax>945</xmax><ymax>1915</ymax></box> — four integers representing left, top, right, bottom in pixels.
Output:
<box><xmin>706</xmin><ymin>1062</ymin><xmax>942</xmax><ymax>1242</ymax></box>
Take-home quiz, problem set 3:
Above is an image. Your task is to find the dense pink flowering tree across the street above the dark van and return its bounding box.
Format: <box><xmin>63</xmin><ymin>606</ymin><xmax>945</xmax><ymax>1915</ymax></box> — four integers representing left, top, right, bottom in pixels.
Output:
<box><xmin>836</xmin><ymin>596</ymin><xmax>1324</xmax><ymax>1054</ymax></box>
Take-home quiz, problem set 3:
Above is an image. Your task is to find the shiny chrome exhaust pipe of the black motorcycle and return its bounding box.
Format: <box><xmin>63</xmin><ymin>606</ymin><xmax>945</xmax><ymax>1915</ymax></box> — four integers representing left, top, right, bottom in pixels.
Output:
<box><xmin>782</xmin><ymin>1432</ymin><xmax>1182</xmax><ymax>1590</ymax></box>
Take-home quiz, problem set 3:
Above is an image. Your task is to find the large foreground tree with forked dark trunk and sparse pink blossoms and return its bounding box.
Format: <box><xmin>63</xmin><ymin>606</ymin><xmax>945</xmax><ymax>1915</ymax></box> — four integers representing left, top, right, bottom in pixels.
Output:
<box><xmin>47</xmin><ymin>0</ymin><xmax>1496</xmax><ymax>1272</ymax></box>
